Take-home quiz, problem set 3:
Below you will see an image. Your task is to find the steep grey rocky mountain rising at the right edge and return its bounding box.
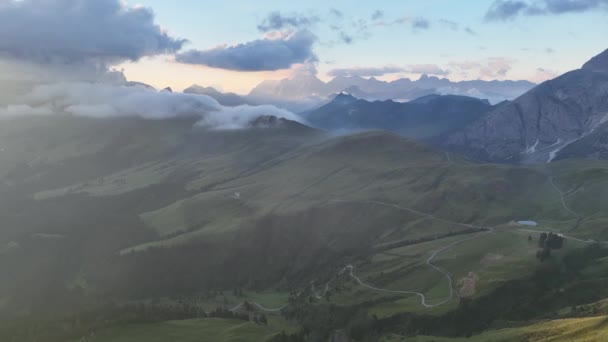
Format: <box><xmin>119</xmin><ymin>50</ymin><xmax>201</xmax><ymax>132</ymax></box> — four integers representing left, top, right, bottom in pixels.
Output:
<box><xmin>443</xmin><ymin>50</ymin><xmax>608</xmax><ymax>163</ymax></box>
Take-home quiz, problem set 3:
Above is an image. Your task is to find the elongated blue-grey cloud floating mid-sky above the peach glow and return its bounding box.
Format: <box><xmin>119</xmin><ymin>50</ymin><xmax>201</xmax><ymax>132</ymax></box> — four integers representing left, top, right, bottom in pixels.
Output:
<box><xmin>175</xmin><ymin>30</ymin><xmax>317</xmax><ymax>71</ymax></box>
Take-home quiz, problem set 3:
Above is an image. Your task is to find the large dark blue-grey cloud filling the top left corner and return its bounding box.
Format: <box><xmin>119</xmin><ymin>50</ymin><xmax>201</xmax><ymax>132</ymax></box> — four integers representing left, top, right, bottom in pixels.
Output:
<box><xmin>0</xmin><ymin>0</ymin><xmax>186</xmax><ymax>65</ymax></box>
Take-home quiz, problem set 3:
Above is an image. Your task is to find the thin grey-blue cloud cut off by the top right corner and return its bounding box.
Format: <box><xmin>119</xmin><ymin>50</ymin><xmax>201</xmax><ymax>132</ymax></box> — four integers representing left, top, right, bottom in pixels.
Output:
<box><xmin>485</xmin><ymin>0</ymin><xmax>608</xmax><ymax>21</ymax></box>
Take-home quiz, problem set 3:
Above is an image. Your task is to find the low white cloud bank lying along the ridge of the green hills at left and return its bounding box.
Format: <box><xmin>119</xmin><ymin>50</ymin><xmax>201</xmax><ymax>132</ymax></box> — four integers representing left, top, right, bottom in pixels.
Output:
<box><xmin>0</xmin><ymin>82</ymin><xmax>301</xmax><ymax>129</ymax></box>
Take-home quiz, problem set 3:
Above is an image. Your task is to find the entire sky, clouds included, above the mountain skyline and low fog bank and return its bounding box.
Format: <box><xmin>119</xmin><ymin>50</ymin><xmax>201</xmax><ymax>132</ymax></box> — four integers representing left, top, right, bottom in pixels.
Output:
<box><xmin>0</xmin><ymin>0</ymin><xmax>608</xmax><ymax>94</ymax></box>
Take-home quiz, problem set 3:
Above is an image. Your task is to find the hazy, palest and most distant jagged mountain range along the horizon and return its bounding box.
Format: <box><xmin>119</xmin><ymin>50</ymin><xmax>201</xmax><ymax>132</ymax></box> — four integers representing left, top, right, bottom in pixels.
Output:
<box><xmin>184</xmin><ymin>74</ymin><xmax>535</xmax><ymax>112</ymax></box>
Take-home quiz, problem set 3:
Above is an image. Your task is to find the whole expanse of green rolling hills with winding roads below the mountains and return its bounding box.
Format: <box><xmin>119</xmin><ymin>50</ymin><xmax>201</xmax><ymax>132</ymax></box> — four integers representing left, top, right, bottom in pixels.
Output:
<box><xmin>0</xmin><ymin>117</ymin><xmax>608</xmax><ymax>341</ymax></box>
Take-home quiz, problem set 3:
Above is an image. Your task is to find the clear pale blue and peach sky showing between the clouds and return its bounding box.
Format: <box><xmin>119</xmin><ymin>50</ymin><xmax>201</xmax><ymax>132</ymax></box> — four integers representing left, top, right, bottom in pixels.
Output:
<box><xmin>119</xmin><ymin>0</ymin><xmax>608</xmax><ymax>93</ymax></box>
